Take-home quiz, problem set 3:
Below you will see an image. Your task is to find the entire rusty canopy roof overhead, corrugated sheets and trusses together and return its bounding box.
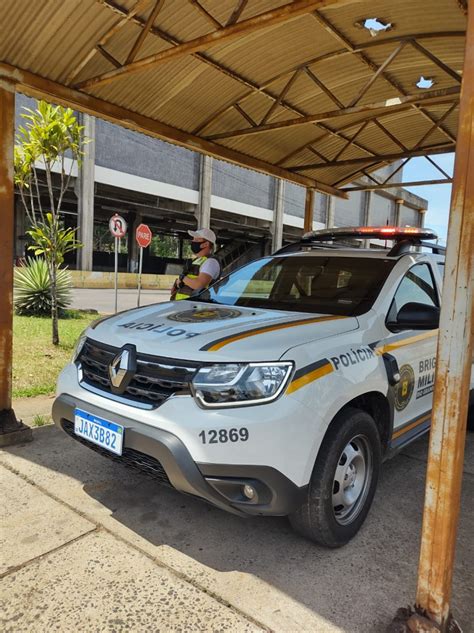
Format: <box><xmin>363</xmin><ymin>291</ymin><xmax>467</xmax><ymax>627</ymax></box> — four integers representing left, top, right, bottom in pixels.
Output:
<box><xmin>0</xmin><ymin>0</ymin><xmax>466</xmax><ymax>197</ymax></box>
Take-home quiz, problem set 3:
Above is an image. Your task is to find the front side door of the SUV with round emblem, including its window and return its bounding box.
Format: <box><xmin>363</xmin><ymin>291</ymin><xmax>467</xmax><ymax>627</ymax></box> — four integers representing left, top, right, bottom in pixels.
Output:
<box><xmin>381</xmin><ymin>262</ymin><xmax>440</xmax><ymax>447</ymax></box>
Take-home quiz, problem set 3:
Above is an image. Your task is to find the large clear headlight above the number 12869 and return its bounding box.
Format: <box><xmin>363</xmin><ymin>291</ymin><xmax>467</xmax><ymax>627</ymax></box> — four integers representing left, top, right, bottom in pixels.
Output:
<box><xmin>191</xmin><ymin>363</ymin><xmax>293</xmax><ymax>408</ymax></box>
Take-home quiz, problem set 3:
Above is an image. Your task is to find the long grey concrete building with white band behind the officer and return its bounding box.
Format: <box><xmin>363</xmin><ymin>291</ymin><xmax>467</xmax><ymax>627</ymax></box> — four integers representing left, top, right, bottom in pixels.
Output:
<box><xmin>12</xmin><ymin>95</ymin><xmax>427</xmax><ymax>273</ymax></box>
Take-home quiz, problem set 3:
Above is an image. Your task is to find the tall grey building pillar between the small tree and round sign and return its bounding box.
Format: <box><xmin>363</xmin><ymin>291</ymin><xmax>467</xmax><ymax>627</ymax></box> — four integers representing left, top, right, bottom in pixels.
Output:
<box><xmin>76</xmin><ymin>114</ymin><xmax>95</xmax><ymax>270</ymax></box>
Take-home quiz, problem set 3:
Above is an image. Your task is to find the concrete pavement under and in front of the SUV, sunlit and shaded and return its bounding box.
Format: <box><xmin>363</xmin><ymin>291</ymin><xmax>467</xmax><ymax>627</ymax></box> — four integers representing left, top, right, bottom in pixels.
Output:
<box><xmin>0</xmin><ymin>418</ymin><xmax>474</xmax><ymax>633</ymax></box>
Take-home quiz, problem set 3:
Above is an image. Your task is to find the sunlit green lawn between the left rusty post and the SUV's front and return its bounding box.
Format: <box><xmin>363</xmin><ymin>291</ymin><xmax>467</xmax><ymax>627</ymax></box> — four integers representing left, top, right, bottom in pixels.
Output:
<box><xmin>13</xmin><ymin>314</ymin><xmax>97</xmax><ymax>398</ymax></box>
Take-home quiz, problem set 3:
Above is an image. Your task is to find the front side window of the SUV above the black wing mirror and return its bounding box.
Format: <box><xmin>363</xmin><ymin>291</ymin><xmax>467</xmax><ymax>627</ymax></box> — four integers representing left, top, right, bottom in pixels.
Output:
<box><xmin>387</xmin><ymin>264</ymin><xmax>439</xmax><ymax>321</ymax></box>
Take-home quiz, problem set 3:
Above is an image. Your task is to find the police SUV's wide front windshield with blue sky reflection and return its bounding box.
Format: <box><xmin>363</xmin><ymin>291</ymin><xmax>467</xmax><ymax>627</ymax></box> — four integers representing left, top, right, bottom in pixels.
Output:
<box><xmin>193</xmin><ymin>255</ymin><xmax>395</xmax><ymax>316</ymax></box>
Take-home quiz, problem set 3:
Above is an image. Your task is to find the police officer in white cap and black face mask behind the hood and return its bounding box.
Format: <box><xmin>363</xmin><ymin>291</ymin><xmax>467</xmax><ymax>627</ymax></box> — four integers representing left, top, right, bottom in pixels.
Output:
<box><xmin>171</xmin><ymin>229</ymin><xmax>221</xmax><ymax>301</ymax></box>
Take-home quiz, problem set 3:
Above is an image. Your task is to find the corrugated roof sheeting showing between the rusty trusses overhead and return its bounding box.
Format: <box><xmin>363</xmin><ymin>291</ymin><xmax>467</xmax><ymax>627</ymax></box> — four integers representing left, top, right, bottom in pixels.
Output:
<box><xmin>0</xmin><ymin>0</ymin><xmax>466</xmax><ymax>193</ymax></box>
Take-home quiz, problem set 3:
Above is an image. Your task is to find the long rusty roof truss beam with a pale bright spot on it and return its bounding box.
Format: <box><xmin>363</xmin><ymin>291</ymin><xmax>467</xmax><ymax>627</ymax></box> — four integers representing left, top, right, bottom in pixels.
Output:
<box><xmin>207</xmin><ymin>86</ymin><xmax>460</xmax><ymax>141</ymax></box>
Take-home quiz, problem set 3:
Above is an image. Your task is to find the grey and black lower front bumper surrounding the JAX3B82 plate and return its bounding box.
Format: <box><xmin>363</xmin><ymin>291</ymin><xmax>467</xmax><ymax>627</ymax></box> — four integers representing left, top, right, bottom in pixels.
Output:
<box><xmin>53</xmin><ymin>393</ymin><xmax>307</xmax><ymax>516</ymax></box>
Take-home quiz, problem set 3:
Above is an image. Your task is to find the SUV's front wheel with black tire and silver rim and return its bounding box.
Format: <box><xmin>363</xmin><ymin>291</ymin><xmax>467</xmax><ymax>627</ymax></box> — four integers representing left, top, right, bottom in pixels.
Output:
<box><xmin>289</xmin><ymin>408</ymin><xmax>382</xmax><ymax>547</ymax></box>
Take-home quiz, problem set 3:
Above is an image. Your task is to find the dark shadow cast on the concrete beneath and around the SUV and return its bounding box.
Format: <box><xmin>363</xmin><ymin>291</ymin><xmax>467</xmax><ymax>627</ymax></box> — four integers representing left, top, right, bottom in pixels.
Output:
<box><xmin>3</xmin><ymin>427</ymin><xmax>474</xmax><ymax>633</ymax></box>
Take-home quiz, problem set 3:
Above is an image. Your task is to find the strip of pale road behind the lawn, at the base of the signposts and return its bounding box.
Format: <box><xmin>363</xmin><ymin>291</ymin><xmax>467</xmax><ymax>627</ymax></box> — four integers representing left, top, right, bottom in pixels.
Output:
<box><xmin>71</xmin><ymin>288</ymin><xmax>170</xmax><ymax>314</ymax></box>
